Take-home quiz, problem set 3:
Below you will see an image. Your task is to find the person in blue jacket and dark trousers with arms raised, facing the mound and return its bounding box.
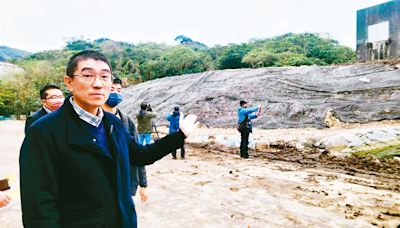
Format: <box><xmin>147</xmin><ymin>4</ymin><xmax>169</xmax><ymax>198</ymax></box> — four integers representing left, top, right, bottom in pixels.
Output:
<box><xmin>237</xmin><ymin>100</ymin><xmax>261</xmax><ymax>159</ymax></box>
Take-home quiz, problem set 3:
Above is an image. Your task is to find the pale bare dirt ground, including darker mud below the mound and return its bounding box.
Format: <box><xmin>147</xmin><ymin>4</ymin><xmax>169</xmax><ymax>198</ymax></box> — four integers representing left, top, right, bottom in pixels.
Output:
<box><xmin>0</xmin><ymin>121</ymin><xmax>400</xmax><ymax>227</ymax></box>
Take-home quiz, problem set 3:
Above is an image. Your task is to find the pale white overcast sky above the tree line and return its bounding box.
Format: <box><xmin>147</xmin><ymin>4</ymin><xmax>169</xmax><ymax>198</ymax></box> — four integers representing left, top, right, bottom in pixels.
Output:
<box><xmin>0</xmin><ymin>0</ymin><xmax>388</xmax><ymax>51</ymax></box>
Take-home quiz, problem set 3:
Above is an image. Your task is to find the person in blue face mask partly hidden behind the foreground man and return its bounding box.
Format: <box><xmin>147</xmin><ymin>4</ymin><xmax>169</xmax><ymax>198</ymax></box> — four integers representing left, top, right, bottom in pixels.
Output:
<box><xmin>103</xmin><ymin>78</ymin><xmax>148</xmax><ymax>202</ymax></box>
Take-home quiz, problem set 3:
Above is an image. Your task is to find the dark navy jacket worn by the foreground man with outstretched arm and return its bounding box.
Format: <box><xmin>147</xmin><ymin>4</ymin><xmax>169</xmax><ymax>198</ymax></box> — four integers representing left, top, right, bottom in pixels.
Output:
<box><xmin>19</xmin><ymin>97</ymin><xmax>185</xmax><ymax>228</ymax></box>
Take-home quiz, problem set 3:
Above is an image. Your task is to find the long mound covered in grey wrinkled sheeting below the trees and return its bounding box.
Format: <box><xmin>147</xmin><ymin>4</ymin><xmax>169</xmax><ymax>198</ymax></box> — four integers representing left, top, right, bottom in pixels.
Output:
<box><xmin>120</xmin><ymin>64</ymin><xmax>400</xmax><ymax>129</ymax></box>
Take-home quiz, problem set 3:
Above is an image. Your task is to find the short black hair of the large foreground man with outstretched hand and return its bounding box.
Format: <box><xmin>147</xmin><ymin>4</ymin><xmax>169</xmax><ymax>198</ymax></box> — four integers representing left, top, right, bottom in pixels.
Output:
<box><xmin>66</xmin><ymin>50</ymin><xmax>112</xmax><ymax>77</ymax></box>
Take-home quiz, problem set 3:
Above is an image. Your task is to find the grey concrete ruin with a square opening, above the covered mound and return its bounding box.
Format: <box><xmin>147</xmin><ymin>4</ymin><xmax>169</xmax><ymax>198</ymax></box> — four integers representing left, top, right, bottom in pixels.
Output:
<box><xmin>357</xmin><ymin>0</ymin><xmax>400</xmax><ymax>61</ymax></box>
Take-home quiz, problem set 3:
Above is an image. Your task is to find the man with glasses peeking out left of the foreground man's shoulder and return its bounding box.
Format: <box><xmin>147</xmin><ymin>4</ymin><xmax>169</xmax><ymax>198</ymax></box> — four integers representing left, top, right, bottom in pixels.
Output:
<box><xmin>25</xmin><ymin>84</ymin><xmax>64</xmax><ymax>134</ymax></box>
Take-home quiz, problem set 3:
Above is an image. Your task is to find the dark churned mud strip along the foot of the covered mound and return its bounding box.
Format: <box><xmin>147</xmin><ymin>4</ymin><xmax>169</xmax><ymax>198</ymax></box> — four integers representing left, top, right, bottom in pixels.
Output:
<box><xmin>190</xmin><ymin>142</ymin><xmax>400</xmax><ymax>192</ymax></box>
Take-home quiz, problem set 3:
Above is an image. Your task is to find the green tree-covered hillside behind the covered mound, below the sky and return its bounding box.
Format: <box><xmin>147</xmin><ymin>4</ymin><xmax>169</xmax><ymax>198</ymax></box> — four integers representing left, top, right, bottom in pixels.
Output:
<box><xmin>0</xmin><ymin>33</ymin><xmax>355</xmax><ymax>115</ymax></box>
